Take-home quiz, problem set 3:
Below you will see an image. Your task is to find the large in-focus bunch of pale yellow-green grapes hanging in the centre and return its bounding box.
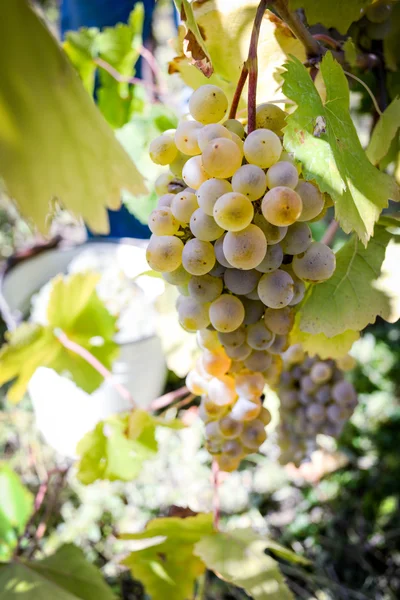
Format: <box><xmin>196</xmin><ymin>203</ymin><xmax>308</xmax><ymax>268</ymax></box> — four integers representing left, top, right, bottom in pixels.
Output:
<box><xmin>147</xmin><ymin>85</ymin><xmax>335</xmax><ymax>470</ymax></box>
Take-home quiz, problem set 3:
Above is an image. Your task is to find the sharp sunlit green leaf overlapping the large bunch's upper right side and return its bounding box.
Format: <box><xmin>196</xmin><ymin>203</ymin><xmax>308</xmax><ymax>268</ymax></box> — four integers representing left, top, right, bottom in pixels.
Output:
<box><xmin>283</xmin><ymin>52</ymin><xmax>400</xmax><ymax>244</ymax></box>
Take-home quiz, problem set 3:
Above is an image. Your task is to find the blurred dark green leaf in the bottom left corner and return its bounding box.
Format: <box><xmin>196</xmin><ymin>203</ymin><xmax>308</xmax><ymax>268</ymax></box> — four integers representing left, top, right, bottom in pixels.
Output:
<box><xmin>0</xmin><ymin>544</ymin><xmax>115</xmax><ymax>600</ymax></box>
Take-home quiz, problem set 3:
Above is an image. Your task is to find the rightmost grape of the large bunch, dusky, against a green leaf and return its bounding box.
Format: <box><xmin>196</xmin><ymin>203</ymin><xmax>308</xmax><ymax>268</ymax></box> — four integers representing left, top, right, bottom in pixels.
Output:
<box><xmin>292</xmin><ymin>242</ymin><xmax>336</xmax><ymax>282</ymax></box>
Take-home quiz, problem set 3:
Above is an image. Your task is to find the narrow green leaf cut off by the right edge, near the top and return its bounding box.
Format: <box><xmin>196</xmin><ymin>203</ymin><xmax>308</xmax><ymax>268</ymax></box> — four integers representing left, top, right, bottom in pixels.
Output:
<box><xmin>367</xmin><ymin>98</ymin><xmax>400</xmax><ymax>165</ymax></box>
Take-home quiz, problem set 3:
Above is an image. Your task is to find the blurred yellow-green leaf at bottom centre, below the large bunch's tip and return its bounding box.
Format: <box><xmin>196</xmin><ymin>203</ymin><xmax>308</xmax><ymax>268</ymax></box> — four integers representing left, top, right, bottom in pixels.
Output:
<box><xmin>121</xmin><ymin>514</ymin><xmax>216</xmax><ymax>600</ymax></box>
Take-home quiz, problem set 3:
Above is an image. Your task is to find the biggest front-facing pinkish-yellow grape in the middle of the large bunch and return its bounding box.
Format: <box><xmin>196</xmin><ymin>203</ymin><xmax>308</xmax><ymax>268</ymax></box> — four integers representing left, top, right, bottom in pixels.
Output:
<box><xmin>223</xmin><ymin>224</ymin><xmax>267</xmax><ymax>270</ymax></box>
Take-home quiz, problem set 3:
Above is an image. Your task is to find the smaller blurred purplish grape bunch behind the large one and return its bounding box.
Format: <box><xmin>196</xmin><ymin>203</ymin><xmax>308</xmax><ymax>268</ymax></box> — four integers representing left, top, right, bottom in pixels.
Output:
<box><xmin>278</xmin><ymin>344</ymin><xmax>357</xmax><ymax>465</ymax></box>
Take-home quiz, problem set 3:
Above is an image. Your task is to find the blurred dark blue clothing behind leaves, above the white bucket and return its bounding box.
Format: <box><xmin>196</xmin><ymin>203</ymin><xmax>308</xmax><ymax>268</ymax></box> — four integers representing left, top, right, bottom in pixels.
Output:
<box><xmin>61</xmin><ymin>0</ymin><xmax>156</xmax><ymax>239</ymax></box>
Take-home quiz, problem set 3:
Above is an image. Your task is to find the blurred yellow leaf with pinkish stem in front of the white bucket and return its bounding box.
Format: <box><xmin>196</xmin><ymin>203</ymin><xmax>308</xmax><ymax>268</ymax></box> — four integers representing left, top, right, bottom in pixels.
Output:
<box><xmin>0</xmin><ymin>272</ymin><xmax>119</xmax><ymax>402</ymax></box>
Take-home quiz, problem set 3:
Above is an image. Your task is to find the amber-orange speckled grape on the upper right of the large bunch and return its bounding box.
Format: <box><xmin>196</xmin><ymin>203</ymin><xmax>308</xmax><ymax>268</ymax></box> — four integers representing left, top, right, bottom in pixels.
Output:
<box><xmin>261</xmin><ymin>186</ymin><xmax>303</xmax><ymax>227</ymax></box>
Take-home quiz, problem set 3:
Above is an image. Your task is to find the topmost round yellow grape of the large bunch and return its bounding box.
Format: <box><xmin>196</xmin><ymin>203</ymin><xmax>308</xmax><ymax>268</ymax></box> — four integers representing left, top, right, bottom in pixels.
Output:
<box><xmin>189</xmin><ymin>84</ymin><xmax>228</xmax><ymax>124</ymax></box>
